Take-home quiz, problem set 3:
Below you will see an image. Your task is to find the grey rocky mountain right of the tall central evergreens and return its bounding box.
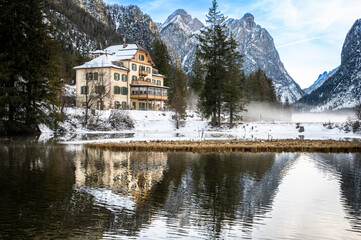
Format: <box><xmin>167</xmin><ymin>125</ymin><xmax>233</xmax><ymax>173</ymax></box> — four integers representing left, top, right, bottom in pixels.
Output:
<box><xmin>226</xmin><ymin>13</ymin><xmax>305</xmax><ymax>103</ymax></box>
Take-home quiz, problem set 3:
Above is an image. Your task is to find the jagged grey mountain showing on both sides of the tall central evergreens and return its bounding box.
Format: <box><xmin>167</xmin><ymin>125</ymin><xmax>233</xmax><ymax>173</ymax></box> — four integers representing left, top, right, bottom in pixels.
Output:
<box><xmin>160</xmin><ymin>9</ymin><xmax>305</xmax><ymax>102</ymax></box>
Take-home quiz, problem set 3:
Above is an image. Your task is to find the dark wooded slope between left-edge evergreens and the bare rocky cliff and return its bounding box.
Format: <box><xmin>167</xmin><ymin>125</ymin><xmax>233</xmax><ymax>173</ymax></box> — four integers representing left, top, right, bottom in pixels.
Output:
<box><xmin>45</xmin><ymin>0</ymin><xmax>123</xmax><ymax>56</ymax></box>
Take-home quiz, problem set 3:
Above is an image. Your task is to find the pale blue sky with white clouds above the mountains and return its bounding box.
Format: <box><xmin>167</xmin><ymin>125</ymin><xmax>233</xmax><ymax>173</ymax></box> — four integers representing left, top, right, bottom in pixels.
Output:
<box><xmin>104</xmin><ymin>0</ymin><xmax>361</xmax><ymax>88</ymax></box>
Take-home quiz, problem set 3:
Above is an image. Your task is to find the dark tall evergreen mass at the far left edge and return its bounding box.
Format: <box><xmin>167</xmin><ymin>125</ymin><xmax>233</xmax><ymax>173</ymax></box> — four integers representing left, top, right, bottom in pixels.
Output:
<box><xmin>0</xmin><ymin>0</ymin><xmax>60</xmax><ymax>134</ymax></box>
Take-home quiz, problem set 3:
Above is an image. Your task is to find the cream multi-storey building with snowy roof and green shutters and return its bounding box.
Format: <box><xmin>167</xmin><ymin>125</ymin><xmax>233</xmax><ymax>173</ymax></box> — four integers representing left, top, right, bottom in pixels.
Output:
<box><xmin>74</xmin><ymin>44</ymin><xmax>168</xmax><ymax>110</ymax></box>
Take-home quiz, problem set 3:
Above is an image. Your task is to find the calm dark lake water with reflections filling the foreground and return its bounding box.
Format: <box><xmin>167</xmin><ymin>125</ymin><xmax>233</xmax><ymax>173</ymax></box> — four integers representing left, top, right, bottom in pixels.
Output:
<box><xmin>0</xmin><ymin>139</ymin><xmax>361</xmax><ymax>239</ymax></box>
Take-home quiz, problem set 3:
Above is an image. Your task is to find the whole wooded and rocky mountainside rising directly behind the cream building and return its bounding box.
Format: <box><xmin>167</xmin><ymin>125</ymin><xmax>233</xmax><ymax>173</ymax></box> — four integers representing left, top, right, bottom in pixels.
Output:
<box><xmin>45</xmin><ymin>0</ymin><xmax>181</xmax><ymax>66</ymax></box>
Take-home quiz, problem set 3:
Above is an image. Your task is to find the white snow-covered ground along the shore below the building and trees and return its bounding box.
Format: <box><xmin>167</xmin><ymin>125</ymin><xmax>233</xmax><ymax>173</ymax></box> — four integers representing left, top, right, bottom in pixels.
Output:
<box><xmin>41</xmin><ymin>109</ymin><xmax>361</xmax><ymax>144</ymax></box>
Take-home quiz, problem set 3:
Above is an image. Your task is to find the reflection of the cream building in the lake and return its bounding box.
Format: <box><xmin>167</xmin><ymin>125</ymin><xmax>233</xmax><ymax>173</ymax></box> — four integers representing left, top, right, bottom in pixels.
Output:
<box><xmin>75</xmin><ymin>149</ymin><xmax>167</xmax><ymax>203</ymax></box>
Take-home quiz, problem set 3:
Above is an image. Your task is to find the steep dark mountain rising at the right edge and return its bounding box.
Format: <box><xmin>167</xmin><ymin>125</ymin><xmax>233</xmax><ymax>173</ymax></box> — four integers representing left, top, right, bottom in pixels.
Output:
<box><xmin>296</xmin><ymin>19</ymin><xmax>361</xmax><ymax>111</ymax></box>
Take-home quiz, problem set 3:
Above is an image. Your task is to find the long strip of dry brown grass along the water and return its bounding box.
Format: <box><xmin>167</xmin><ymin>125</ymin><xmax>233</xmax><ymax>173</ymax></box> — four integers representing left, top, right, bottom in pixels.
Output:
<box><xmin>85</xmin><ymin>140</ymin><xmax>361</xmax><ymax>153</ymax></box>
